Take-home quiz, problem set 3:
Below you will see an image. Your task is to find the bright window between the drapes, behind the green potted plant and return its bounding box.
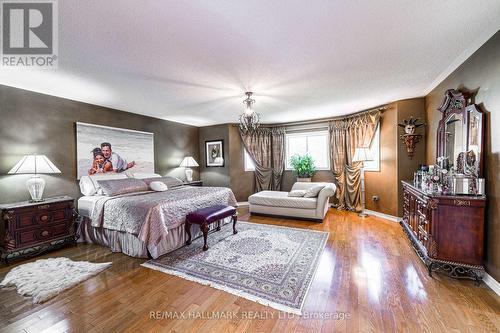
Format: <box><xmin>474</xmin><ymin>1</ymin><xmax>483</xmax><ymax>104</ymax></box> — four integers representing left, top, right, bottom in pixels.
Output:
<box><xmin>286</xmin><ymin>130</ymin><xmax>330</xmax><ymax>170</ymax></box>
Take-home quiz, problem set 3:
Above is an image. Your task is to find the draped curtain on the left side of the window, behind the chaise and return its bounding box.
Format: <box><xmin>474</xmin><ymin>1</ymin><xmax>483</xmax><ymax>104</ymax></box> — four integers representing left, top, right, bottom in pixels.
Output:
<box><xmin>240</xmin><ymin>127</ymin><xmax>285</xmax><ymax>192</ymax></box>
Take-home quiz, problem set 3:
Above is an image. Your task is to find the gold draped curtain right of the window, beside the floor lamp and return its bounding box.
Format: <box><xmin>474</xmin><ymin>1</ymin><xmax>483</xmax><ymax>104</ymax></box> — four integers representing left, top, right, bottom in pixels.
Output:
<box><xmin>329</xmin><ymin>111</ymin><xmax>381</xmax><ymax>211</ymax></box>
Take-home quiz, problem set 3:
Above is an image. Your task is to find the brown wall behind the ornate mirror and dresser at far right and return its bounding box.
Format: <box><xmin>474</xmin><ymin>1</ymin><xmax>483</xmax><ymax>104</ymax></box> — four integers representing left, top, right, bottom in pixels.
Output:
<box><xmin>426</xmin><ymin>32</ymin><xmax>500</xmax><ymax>281</ymax></box>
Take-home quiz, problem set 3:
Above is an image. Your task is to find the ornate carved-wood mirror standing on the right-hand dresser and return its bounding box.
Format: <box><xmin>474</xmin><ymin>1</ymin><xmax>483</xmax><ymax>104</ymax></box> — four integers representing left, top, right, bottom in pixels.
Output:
<box><xmin>436</xmin><ymin>89</ymin><xmax>484</xmax><ymax>177</ymax></box>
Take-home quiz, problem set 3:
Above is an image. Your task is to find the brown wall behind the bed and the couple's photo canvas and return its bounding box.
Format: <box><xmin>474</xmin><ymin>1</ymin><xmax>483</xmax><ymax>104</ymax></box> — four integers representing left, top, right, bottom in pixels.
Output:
<box><xmin>0</xmin><ymin>85</ymin><xmax>198</xmax><ymax>203</ymax></box>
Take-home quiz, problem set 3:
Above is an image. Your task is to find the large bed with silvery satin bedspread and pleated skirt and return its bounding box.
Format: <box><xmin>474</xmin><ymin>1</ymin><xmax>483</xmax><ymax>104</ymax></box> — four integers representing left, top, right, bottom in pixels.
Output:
<box><xmin>78</xmin><ymin>175</ymin><xmax>237</xmax><ymax>258</ymax></box>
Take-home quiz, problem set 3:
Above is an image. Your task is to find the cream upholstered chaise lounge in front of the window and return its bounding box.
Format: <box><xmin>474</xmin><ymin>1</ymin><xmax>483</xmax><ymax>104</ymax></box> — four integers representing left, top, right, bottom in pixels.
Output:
<box><xmin>248</xmin><ymin>182</ymin><xmax>336</xmax><ymax>221</ymax></box>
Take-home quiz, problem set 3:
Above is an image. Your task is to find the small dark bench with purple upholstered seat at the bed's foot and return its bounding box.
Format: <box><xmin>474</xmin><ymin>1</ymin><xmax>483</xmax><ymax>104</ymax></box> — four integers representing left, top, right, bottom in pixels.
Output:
<box><xmin>186</xmin><ymin>205</ymin><xmax>238</xmax><ymax>251</ymax></box>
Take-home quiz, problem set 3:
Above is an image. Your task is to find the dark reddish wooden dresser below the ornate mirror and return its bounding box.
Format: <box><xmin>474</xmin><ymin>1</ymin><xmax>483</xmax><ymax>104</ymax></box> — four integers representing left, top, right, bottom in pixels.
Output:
<box><xmin>401</xmin><ymin>182</ymin><xmax>486</xmax><ymax>283</ymax></box>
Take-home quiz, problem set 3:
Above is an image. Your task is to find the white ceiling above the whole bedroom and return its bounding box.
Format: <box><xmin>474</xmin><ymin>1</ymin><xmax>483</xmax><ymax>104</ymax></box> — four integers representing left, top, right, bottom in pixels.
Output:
<box><xmin>0</xmin><ymin>0</ymin><xmax>500</xmax><ymax>126</ymax></box>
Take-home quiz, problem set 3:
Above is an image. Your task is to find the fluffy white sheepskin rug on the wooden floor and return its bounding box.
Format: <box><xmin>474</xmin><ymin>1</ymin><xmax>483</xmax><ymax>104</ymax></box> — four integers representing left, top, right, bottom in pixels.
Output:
<box><xmin>0</xmin><ymin>258</ymin><xmax>111</xmax><ymax>303</ymax></box>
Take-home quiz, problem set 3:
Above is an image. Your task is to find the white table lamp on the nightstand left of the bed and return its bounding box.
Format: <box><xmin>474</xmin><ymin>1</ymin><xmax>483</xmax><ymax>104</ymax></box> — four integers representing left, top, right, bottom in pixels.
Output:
<box><xmin>8</xmin><ymin>154</ymin><xmax>61</xmax><ymax>202</ymax></box>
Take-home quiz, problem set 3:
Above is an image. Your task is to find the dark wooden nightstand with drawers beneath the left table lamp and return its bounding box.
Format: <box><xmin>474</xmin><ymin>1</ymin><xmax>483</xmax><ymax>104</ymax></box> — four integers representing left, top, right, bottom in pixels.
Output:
<box><xmin>0</xmin><ymin>196</ymin><xmax>77</xmax><ymax>262</ymax></box>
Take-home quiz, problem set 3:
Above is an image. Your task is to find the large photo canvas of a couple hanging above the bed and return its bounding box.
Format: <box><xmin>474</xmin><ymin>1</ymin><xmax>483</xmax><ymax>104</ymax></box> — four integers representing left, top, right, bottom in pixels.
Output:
<box><xmin>76</xmin><ymin>123</ymin><xmax>155</xmax><ymax>179</ymax></box>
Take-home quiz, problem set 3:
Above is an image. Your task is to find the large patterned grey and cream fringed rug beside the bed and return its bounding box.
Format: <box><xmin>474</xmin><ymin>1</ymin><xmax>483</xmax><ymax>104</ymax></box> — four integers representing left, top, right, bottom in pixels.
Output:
<box><xmin>142</xmin><ymin>222</ymin><xmax>329</xmax><ymax>314</ymax></box>
